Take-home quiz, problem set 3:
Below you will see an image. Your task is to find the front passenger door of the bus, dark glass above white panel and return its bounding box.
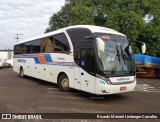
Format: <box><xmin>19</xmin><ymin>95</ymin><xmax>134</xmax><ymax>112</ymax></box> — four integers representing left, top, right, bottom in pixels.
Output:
<box><xmin>80</xmin><ymin>48</ymin><xmax>95</xmax><ymax>93</ymax></box>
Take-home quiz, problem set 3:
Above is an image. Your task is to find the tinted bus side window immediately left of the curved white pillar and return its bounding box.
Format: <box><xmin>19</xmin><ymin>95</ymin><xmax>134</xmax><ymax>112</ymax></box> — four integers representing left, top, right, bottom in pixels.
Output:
<box><xmin>54</xmin><ymin>33</ymin><xmax>69</xmax><ymax>53</ymax></box>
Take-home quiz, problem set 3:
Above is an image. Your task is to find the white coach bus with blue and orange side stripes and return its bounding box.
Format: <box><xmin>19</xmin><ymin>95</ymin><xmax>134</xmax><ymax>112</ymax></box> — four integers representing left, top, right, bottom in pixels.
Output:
<box><xmin>13</xmin><ymin>25</ymin><xmax>145</xmax><ymax>95</ymax></box>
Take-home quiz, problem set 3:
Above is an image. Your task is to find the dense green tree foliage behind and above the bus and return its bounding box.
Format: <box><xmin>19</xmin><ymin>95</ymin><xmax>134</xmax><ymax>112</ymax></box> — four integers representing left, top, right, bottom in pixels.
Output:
<box><xmin>46</xmin><ymin>0</ymin><xmax>160</xmax><ymax>56</ymax></box>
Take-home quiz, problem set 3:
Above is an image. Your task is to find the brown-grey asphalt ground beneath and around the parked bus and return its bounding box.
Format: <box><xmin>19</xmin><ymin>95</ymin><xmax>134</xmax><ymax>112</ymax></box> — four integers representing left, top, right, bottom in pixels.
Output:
<box><xmin>0</xmin><ymin>68</ymin><xmax>160</xmax><ymax>122</ymax></box>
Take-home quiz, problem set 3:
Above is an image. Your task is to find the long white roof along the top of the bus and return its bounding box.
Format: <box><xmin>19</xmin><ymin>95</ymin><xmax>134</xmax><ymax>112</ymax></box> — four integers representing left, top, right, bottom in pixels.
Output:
<box><xmin>15</xmin><ymin>25</ymin><xmax>125</xmax><ymax>45</ymax></box>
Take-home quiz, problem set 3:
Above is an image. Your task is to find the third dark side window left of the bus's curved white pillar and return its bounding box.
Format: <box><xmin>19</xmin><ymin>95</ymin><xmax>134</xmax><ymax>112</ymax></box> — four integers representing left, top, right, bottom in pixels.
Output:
<box><xmin>32</xmin><ymin>39</ymin><xmax>41</xmax><ymax>53</ymax></box>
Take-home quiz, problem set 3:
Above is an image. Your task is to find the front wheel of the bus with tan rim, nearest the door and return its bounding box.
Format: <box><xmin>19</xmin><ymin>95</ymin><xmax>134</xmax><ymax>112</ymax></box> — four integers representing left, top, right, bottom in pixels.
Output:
<box><xmin>58</xmin><ymin>74</ymin><xmax>71</xmax><ymax>92</ymax></box>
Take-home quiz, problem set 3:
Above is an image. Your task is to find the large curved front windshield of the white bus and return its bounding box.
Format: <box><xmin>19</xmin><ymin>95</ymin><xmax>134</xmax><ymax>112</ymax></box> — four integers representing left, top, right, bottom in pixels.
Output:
<box><xmin>95</xmin><ymin>33</ymin><xmax>135</xmax><ymax>74</ymax></box>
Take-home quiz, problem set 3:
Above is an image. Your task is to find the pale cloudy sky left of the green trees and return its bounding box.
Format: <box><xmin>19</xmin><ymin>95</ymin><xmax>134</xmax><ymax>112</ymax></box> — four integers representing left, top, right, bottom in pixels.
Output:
<box><xmin>0</xmin><ymin>0</ymin><xmax>65</xmax><ymax>49</ymax></box>
